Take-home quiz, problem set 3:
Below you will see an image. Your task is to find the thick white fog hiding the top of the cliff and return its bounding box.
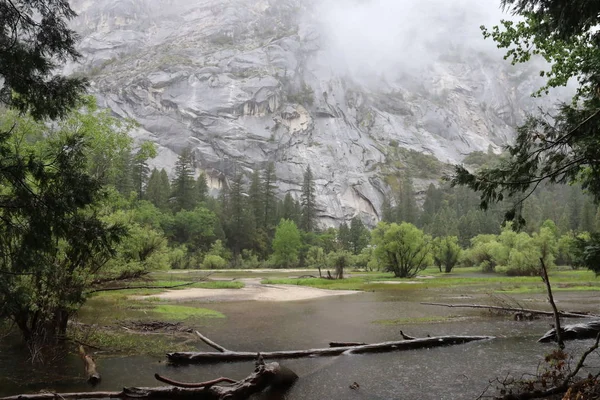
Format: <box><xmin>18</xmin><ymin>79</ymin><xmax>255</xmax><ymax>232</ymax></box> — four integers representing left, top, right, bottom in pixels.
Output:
<box><xmin>310</xmin><ymin>0</ymin><xmax>511</xmax><ymax>78</ymax></box>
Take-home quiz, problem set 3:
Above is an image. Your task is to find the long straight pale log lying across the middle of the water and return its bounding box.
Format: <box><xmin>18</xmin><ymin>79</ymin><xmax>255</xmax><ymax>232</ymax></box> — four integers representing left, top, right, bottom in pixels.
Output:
<box><xmin>167</xmin><ymin>336</ymin><xmax>493</xmax><ymax>364</ymax></box>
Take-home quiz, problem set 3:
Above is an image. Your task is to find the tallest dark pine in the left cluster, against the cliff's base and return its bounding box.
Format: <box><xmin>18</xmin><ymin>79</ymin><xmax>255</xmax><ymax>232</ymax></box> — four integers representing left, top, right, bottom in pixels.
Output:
<box><xmin>172</xmin><ymin>147</ymin><xmax>197</xmax><ymax>212</ymax></box>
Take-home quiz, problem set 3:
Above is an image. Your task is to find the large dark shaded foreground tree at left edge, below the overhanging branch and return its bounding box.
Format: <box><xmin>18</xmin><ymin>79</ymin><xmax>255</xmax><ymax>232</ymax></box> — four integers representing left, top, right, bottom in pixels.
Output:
<box><xmin>0</xmin><ymin>121</ymin><xmax>125</xmax><ymax>343</ymax></box>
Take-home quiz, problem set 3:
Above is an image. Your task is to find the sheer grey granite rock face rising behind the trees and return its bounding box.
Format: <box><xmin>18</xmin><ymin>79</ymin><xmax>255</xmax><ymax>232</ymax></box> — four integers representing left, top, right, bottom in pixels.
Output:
<box><xmin>70</xmin><ymin>0</ymin><xmax>564</xmax><ymax>226</ymax></box>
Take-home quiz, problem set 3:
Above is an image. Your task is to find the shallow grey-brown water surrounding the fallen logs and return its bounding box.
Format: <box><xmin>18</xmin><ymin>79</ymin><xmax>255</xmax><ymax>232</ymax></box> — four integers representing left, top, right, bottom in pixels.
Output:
<box><xmin>0</xmin><ymin>290</ymin><xmax>597</xmax><ymax>400</ymax></box>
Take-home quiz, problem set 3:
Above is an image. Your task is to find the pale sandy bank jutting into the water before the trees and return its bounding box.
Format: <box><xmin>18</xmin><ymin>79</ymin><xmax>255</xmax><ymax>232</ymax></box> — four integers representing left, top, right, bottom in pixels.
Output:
<box><xmin>136</xmin><ymin>279</ymin><xmax>360</xmax><ymax>302</ymax></box>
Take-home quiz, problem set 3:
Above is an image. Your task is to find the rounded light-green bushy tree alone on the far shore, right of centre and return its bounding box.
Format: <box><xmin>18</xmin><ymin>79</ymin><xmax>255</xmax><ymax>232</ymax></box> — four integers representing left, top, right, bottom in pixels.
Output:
<box><xmin>371</xmin><ymin>222</ymin><xmax>432</xmax><ymax>278</ymax></box>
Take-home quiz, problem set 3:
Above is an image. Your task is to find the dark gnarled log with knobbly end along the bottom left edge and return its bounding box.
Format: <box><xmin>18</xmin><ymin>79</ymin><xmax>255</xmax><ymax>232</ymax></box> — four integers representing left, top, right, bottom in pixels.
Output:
<box><xmin>0</xmin><ymin>363</ymin><xmax>298</xmax><ymax>400</ymax></box>
